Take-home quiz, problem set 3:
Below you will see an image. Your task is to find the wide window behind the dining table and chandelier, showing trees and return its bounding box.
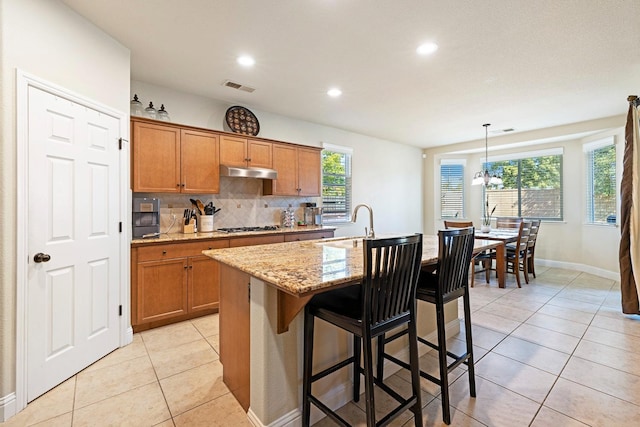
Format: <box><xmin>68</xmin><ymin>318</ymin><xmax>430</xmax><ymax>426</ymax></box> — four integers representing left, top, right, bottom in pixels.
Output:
<box><xmin>483</xmin><ymin>149</ymin><xmax>563</xmax><ymax>221</ymax></box>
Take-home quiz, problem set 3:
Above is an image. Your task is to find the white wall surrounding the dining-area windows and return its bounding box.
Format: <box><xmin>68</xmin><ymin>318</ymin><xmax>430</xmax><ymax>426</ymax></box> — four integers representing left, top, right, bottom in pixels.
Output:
<box><xmin>424</xmin><ymin>116</ymin><xmax>626</xmax><ymax>279</ymax></box>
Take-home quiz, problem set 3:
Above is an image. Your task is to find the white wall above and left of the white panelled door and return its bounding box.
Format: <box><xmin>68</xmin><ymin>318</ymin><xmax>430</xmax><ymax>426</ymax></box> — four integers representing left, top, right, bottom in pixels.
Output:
<box><xmin>0</xmin><ymin>0</ymin><xmax>130</xmax><ymax>414</ymax></box>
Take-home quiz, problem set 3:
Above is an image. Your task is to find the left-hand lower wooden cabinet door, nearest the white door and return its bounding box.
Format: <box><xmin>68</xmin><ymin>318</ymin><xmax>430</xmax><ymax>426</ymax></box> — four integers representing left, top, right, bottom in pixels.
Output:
<box><xmin>136</xmin><ymin>258</ymin><xmax>188</xmax><ymax>324</ymax></box>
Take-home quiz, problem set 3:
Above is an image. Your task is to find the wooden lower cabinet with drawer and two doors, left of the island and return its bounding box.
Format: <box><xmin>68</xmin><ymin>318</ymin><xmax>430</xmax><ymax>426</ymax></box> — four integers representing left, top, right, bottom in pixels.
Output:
<box><xmin>131</xmin><ymin>240</ymin><xmax>229</xmax><ymax>332</ymax></box>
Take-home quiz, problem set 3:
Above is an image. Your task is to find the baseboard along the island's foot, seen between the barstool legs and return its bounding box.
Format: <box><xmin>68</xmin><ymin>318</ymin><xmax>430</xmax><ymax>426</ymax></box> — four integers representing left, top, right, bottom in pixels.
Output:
<box><xmin>247</xmin><ymin>319</ymin><xmax>460</xmax><ymax>427</ymax></box>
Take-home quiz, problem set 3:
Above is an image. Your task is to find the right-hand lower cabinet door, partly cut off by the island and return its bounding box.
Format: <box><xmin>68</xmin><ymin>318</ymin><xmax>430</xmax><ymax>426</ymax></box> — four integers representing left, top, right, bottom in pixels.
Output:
<box><xmin>188</xmin><ymin>255</ymin><xmax>220</xmax><ymax>312</ymax></box>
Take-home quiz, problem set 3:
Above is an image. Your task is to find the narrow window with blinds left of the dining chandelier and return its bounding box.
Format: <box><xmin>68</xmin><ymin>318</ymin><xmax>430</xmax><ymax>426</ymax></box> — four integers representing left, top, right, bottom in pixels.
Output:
<box><xmin>440</xmin><ymin>160</ymin><xmax>464</xmax><ymax>218</ymax></box>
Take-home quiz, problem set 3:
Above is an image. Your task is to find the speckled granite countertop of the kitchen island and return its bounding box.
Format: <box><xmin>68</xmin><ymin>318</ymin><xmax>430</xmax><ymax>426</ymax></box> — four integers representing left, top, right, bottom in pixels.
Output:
<box><xmin>203</xmin><ymin>236</ymin><xmax>438</xmax><ymax>296</ymax></box>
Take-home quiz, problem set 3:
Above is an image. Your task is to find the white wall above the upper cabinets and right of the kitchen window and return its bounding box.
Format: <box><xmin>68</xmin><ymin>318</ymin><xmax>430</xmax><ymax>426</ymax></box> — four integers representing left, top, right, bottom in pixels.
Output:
<box><xmin>131</xmin><ymin>81</ymin><xmax>422</xmax><ymax>236</ymax></box>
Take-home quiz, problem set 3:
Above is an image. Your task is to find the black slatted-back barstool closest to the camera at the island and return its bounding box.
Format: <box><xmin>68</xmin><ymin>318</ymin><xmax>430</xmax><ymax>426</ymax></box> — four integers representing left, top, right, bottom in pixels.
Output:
<box><xmin>302</xmin><ymin>234</ymin><xmax>422</xmax><ymax>426</ymax></box>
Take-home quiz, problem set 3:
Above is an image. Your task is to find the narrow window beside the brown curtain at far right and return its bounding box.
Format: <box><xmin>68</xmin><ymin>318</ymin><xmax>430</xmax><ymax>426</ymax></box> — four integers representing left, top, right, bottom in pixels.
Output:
<box><xmin>583</xmin><ymin>137</ymin><xmax>617</xmax><ymax>224</ymax></box>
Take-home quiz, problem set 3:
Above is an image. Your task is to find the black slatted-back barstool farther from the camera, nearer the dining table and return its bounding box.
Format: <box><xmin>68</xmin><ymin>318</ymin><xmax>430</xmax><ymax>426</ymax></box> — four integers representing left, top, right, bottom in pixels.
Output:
<box><xmin>377</xmin><ymin>227</ymin><xmax>476</xmax><ymax>424</ymax></box>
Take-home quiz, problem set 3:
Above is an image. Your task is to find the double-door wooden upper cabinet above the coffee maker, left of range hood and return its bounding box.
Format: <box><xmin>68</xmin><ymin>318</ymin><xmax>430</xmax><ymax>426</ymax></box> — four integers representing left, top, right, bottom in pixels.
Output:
<box><xmin>131</xmin><ymin>121</ymin><xmax>220</xmax><ymax>194</ymax></box>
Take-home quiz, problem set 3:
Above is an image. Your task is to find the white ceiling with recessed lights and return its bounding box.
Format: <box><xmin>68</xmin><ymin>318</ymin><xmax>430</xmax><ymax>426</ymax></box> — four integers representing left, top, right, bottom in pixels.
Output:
<box><xmin>63</xmin><ymin>0</ymin><xmax>640</xmax><ymax>148</ymax></box>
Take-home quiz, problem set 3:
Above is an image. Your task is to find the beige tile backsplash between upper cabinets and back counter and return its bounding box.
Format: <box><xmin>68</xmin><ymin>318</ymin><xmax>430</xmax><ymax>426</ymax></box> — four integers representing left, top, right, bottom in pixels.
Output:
<box><xmin>138</xmin><ymin>177</ymin><xmax>321</xmax><ymax>233</ymax></box>
